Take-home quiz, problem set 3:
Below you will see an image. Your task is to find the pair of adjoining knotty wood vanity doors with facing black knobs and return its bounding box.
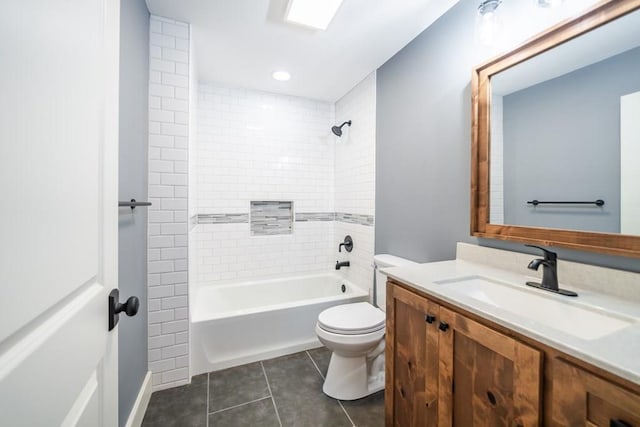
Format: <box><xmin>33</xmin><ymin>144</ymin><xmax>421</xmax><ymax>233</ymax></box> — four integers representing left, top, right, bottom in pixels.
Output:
<box><xmin>385</xmin><ymin>282</ymin><xmax>542</xmax><ymax>427</ymax></box>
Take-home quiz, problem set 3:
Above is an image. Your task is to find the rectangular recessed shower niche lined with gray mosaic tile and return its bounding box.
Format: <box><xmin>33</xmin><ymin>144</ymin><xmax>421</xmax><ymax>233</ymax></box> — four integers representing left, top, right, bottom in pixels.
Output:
<box><xmin>250</xmin><ymin>200</ymin><xmax>293</xmax><ymax>236</ymax></box>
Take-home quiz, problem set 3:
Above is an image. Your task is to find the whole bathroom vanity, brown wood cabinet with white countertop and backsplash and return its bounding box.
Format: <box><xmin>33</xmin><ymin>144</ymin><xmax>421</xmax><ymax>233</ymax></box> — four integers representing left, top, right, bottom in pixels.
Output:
<box><xmin>385</xmin><ymin>244</ymin><xmax>640</xmax><ymax>427</ymax></box>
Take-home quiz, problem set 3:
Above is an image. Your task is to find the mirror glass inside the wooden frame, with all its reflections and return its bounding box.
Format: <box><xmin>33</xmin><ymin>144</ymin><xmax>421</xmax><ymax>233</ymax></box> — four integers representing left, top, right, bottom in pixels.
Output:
<box><xmin>489</xmin><ymin>7</ymin><xmax>640</xmax><ymax>235</ymax></box>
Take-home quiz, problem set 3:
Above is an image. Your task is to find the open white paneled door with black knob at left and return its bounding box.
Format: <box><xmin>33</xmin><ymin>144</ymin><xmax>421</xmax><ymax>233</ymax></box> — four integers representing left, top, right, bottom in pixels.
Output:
<box><xmin>0</xmin><ymin>0</ymin><xmax>119</xmax><ymax>427</ymax></box>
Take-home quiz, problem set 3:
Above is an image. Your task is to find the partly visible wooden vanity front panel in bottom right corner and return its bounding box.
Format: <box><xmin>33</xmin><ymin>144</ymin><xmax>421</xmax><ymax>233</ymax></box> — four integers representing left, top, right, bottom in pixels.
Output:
<box><xmin>551</xmin><ymin>359</ymin><xmax>640</xmax><ymax>427</ymax></box>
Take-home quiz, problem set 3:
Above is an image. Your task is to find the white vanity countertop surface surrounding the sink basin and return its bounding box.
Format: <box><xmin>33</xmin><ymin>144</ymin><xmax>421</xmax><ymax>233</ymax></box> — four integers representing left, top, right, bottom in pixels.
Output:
<box><xmin>381</xmin><ymin>260</ymin><xmax>640</xmax><ymax>385</ymax></box>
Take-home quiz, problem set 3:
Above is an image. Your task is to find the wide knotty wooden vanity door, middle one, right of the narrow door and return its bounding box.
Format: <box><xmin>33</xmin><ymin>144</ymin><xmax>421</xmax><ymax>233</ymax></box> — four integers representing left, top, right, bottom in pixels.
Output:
<box><xmin>438</xmin><ymin>307</ymin><xmax>542</xmax><ymax>427</ymax></box>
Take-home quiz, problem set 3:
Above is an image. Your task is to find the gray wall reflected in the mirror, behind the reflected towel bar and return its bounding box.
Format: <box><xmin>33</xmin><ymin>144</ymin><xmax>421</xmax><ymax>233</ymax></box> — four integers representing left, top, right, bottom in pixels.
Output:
<box><xmin>503</xmin><ymin>48</ymin><xmax>640</xmax><ymax>233</ymax></box>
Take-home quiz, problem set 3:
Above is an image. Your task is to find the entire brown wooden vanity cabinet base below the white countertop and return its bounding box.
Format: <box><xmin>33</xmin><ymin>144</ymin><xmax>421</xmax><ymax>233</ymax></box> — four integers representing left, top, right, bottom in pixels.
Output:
<box><xmin>385</xmin><ymin>280</ymin><xmax>640</xmax><ymax>427</ymax></box>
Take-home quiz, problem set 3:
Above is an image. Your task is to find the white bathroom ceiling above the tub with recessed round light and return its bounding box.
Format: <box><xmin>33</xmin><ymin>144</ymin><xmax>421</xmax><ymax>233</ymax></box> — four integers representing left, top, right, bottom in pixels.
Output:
<box><xmin>147</xmin><ymin>0</ymin><xmax>458</xmax><ymax>102</ymax></box>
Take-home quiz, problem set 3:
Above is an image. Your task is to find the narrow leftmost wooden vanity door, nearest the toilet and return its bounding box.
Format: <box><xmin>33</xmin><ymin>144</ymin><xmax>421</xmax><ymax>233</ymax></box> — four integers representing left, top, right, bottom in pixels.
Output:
<box><xmin>385</xmin><ymin>283</ymin><xmax>439</xmax><ymax>427</ymax></box>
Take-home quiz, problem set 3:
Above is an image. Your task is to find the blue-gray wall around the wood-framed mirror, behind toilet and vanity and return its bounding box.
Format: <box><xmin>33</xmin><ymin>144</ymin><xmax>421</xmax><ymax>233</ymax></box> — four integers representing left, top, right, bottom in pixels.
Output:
<box><xmin>375</xmin><ymin>0</ymin><xmax>640</xmax><ymax>271</ymax></box>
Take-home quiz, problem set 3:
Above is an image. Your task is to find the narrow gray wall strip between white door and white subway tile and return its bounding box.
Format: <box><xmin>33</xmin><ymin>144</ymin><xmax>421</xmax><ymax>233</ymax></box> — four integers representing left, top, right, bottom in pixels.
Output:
<box><xmin>118</xmin><ymin>0</ymin><xmax>149</xmax><ymax>426</ymax></box>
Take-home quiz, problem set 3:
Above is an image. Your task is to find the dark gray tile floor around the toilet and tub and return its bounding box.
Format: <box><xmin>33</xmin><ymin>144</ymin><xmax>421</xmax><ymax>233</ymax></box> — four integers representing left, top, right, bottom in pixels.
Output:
<box><xmin>142</xmin><ymin>348</ymin><xmax>384</xmax><ymax>427</ymax></box>
